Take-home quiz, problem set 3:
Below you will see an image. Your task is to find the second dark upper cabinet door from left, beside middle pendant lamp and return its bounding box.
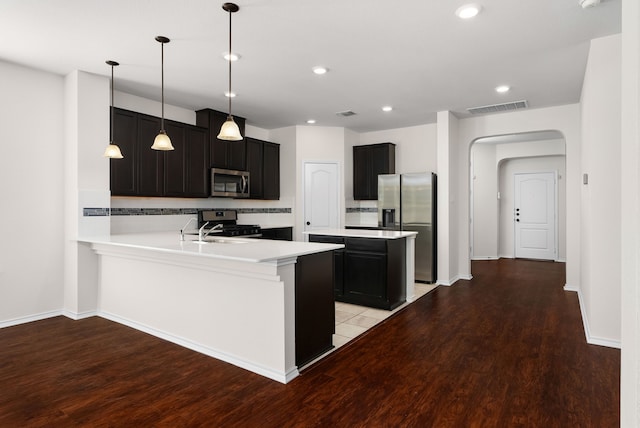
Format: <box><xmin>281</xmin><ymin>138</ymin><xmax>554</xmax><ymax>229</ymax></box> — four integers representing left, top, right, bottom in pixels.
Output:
<box><xmin>138</xmin><ymin>114</ymin><xmax>164</xmax><ymax>196</ymax></box>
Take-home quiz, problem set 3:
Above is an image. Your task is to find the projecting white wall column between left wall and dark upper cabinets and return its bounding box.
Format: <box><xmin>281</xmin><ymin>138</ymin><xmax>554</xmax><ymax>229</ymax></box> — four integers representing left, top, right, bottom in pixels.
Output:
<box><xmin>64</xmin><ymin>71</ymin><xmax>110</xmax><ymax>319</ymax></box>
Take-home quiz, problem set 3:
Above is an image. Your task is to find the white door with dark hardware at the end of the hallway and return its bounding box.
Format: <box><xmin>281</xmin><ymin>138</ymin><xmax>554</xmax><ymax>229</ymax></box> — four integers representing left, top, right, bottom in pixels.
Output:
<box><xmin>514</xmin><ymin>172</ymin><xmax>557</xmax><ymax>260</ymax></box>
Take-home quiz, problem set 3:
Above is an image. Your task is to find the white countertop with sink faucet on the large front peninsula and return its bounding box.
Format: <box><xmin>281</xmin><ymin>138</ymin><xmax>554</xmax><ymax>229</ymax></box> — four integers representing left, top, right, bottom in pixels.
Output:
<box><xmin>78</xmin><ymin>232</ymin><xmax>344</xmax><ymax>263</ymax></box>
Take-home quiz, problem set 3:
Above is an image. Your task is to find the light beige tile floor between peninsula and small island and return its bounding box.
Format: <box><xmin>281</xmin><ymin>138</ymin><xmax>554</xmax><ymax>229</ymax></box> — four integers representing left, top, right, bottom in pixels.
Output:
<box><xmin>333</xmin><ymin>282</ymin><xmax>437</xmax><ymax>349</ymax></box>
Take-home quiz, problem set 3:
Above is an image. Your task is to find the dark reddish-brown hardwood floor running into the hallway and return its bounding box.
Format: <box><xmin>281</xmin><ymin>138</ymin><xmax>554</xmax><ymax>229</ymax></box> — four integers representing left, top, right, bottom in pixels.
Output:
<box><xmin>0</xmin><ymin>259</ymin><xmax>620</xmax><ymax>427</ymax></box>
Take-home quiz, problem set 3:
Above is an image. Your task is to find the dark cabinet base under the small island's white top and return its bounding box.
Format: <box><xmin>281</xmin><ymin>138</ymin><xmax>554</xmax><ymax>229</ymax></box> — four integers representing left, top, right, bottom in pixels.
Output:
<box><xmin>309</xmin><ymin>235</ymin><xmax>407</xmax><ymax>310</ymax></box>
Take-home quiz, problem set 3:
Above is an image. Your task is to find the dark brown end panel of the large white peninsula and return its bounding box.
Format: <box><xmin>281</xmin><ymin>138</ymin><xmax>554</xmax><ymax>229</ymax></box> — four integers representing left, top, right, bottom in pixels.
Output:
<box><xmin>295</xmin><ymin>251</ymin><xmax>335</xmax><ymax>367</ymax></box>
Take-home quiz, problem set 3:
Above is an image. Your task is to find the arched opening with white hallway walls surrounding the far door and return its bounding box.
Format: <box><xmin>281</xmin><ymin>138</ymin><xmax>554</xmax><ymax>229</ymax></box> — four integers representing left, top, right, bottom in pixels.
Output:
<box><xmin>469</xmin><ymin>130</ymin><xmax>566</xmax><ymax>270</ymax></box>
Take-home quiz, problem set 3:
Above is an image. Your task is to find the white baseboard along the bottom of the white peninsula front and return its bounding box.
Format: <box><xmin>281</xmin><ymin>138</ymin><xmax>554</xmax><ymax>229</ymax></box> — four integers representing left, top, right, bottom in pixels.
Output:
<box><xmin>98</xmin><ymin>311</ymin><xmax>300</xmax><ymax>383</ymax></box>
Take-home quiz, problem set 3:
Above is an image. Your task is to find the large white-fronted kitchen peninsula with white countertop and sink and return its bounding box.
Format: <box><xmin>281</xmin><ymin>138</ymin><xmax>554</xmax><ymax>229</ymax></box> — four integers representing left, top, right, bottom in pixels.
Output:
<box><xmin>80</xmin><ymin>232</ymin><xmax>342</xmax><ymax>383</ymax></box>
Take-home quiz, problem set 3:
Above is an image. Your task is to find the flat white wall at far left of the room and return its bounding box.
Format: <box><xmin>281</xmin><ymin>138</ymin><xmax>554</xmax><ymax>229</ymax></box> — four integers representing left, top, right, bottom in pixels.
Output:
<box><xmin>0</xmin><ymin>61</ymin><xmax>64</xmax><ymax>327</ymax></box>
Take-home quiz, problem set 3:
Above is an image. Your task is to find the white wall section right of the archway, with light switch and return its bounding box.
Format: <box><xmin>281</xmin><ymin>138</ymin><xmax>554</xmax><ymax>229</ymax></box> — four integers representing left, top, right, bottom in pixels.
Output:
<box><xmin>580</xmin><ymin>35</ymin><xmax>621</xmax><ymax>344</ymax></box>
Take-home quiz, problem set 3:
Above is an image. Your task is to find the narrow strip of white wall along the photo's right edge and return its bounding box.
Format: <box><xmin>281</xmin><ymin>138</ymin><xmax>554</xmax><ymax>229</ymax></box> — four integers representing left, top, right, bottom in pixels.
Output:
<box><xmin>620</xmin><ymin>0</ymin><xmax>640</xmax><ymax>427</ymax></box>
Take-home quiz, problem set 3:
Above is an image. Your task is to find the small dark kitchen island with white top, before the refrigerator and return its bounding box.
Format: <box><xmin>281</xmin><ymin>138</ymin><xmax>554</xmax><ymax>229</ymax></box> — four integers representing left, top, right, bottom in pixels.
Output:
<box><xmin>304</xmin><ymin>229</ymin><xmax>417</xmax><ymax>310</ymax></box>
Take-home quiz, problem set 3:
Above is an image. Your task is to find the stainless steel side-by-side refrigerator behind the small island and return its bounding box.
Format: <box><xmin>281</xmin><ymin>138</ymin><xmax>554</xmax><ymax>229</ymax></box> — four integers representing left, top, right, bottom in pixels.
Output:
<box><xmin>378</xmin><ymin>172</ymin><xmax>437</xmax><ymax>284</ymax></box>
